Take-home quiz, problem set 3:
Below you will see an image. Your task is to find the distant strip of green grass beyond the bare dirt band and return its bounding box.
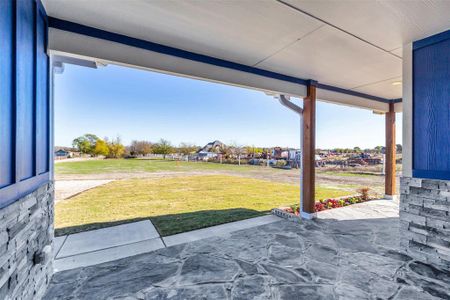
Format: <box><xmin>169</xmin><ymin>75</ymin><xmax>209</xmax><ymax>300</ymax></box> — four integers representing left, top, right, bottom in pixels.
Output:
<box><xmin>55</xmin><ymin>159</ymin><xmax>259</xmax><ymax>174</ymax></box>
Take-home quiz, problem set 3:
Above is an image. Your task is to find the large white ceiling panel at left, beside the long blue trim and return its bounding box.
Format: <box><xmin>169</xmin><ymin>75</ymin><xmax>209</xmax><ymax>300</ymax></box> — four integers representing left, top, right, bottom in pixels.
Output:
<box><xmin>44</xmin><ymin>0</ymin><xmax>323</xmax><ymax>65</ymax></box>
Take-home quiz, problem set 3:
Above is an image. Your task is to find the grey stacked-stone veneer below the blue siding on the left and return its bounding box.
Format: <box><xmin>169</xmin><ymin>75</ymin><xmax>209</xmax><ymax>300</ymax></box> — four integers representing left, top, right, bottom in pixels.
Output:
<box><xmin>0</xmin><ymin>183</ymin><xmax>54</xmax><ymax>299</ymax></box>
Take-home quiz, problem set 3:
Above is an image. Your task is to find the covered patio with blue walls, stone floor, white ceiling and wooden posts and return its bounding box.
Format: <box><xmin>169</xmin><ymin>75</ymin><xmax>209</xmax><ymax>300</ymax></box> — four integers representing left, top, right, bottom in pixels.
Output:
<box><xmin>0</xmin><ymin>0</ymin><xmax>450</xmax><ymax>299</ymax></box>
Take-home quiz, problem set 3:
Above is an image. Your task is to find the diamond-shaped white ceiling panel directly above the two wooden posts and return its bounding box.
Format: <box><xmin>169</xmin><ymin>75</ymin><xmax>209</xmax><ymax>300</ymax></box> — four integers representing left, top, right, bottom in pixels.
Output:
<box><xmin>258</xmin><ymin>26</ymin><xmax>402</xmax><ymax>96</ymax></box>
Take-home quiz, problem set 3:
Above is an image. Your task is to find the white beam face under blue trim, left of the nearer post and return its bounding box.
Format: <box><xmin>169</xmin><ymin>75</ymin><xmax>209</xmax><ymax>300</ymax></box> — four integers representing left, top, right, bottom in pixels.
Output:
<box><xmin>49</xmin><ymin>28</ymin><xmax>310</xmax><ymax>102</ymax></box>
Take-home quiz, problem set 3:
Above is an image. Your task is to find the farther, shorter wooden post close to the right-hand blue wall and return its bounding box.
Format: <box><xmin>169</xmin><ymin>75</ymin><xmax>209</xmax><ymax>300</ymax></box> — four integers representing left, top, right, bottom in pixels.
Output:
<box><xmin>385</xmin><ymin>103</ymin><xmax>397</xmax><ymax>196</ymax></box>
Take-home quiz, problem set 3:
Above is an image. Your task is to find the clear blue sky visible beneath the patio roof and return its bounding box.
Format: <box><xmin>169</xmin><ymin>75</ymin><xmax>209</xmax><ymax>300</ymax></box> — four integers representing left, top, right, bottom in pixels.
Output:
<box><xmin>55</xmin><ymin>65</ymin><xmax>401</xmax><ymax>148</ymax></box>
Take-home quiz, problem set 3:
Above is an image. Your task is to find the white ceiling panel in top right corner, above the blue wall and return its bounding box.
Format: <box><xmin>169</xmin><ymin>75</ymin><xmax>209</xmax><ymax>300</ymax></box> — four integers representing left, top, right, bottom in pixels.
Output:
<box><xmin>282</xmin><ymin>0</ymin><xmax>450</xmax><ymax>51</ymax></box>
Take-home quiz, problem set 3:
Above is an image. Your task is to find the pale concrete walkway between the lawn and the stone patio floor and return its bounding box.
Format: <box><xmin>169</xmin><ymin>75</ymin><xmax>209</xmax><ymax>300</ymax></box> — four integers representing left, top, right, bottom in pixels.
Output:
<box><xmin>54</xmin><ymin>215</ymin><xmax>279</xmax><ymax>272</ymax></box>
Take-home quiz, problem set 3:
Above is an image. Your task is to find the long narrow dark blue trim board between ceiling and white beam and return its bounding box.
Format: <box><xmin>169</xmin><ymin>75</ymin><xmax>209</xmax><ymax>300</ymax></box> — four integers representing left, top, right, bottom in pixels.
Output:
<box><xmin>48</xmin><ymin>17</ymin><xmax>398</xmax><ymax>103</ymax></box>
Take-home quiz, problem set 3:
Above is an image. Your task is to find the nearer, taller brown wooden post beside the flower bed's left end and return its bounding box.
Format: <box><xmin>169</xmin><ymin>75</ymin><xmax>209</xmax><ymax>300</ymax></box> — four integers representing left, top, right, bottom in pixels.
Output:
<box><xmin>301</xmin><ymin>84</ymin><xmax>316</xmax><ymax>214</ymax></box>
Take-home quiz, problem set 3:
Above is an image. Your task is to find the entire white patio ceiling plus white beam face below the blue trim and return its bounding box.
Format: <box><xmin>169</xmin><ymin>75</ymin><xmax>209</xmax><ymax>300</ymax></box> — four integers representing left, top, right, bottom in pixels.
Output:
<box><xmin>43</xmin><ymin>0</ymin><xmax>450</xmax><ymax>111</ymax></box>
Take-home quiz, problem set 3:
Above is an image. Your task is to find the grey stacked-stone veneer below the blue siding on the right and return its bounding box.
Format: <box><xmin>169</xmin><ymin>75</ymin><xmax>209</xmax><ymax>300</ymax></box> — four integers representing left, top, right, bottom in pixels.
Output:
<box><xmin>400</xmin><ymin>177</ymin><xmax>450</xmax><ymax>269</ymax></box>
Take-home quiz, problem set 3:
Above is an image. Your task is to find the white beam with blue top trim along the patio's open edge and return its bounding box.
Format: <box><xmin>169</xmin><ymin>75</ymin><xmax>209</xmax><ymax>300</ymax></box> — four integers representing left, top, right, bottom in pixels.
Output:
<box><xmin>49</xmin><ymin>18</ymin><xmax>401</xmax><ymax>112</ymax></box>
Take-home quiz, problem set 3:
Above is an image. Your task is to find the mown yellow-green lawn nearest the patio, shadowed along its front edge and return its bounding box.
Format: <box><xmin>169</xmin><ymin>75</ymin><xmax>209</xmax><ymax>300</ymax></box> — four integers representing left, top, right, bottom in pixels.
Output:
<box><xmin>55</xmin><ymin>176</ymin><xmax>348</xmax><ymax>236</ymax></box>
